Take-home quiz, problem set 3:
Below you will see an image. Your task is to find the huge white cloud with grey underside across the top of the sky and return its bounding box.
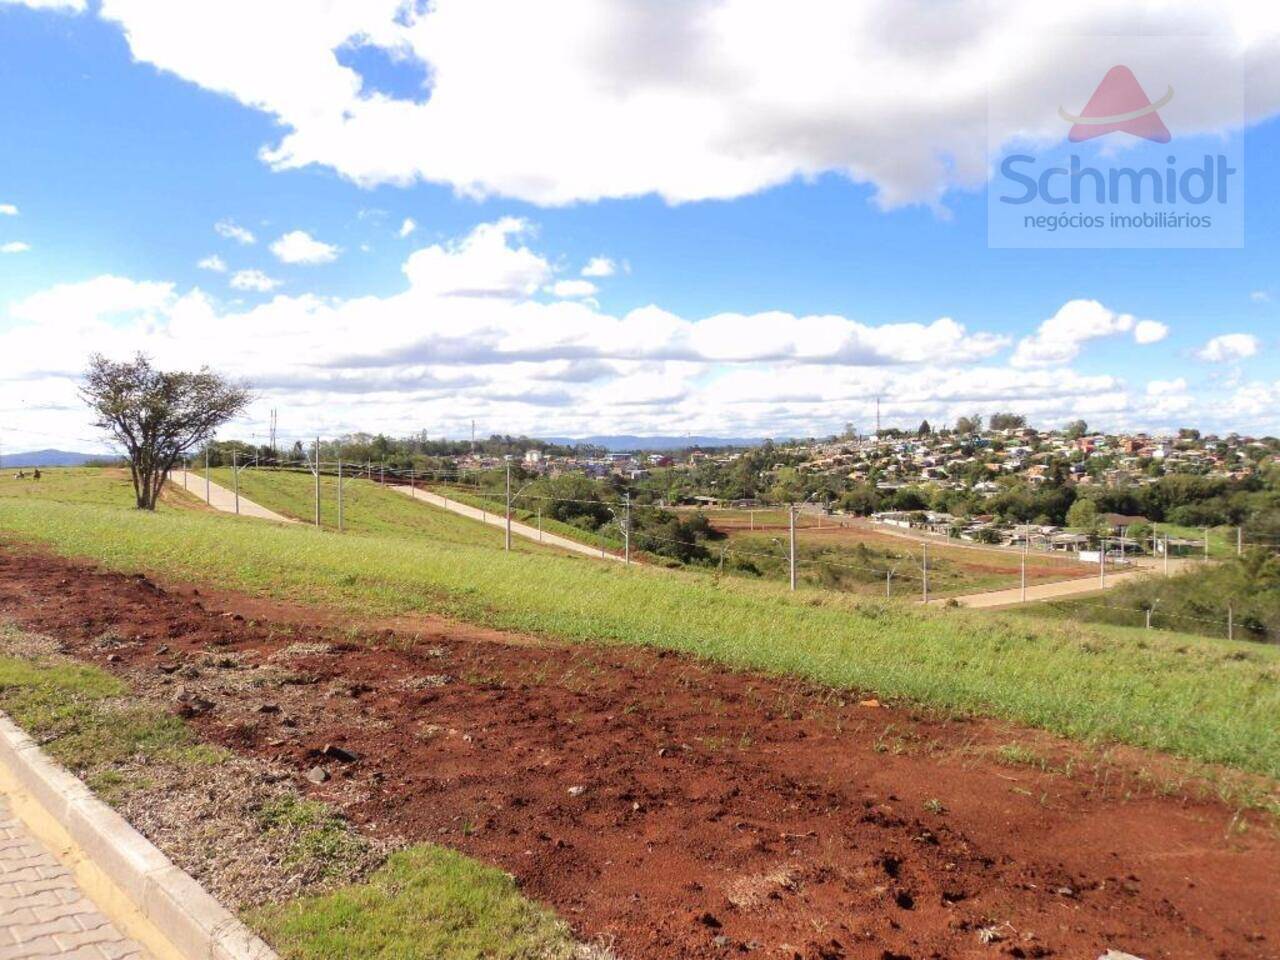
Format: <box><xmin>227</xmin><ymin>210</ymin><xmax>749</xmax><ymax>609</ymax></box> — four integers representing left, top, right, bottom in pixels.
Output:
<box><xmin>87</xmin><ymin>0</ymin><xmax>1280</xmax><ymax>206</ymax></box>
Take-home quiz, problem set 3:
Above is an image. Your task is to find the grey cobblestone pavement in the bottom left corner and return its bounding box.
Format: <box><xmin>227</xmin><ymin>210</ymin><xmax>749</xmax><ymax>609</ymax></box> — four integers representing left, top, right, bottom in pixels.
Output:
<box><xmin>0</xmin><ymin>796</ymin><xmax>150</xmax><ymax>960</ymax></box>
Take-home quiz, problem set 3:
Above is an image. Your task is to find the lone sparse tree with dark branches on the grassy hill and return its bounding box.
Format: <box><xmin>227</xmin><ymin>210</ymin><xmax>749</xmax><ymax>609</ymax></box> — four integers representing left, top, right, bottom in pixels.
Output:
<box><xmin>81</xmin><ymin>353</ymin><xmax>252</xmax><ymax>509</ymax></box>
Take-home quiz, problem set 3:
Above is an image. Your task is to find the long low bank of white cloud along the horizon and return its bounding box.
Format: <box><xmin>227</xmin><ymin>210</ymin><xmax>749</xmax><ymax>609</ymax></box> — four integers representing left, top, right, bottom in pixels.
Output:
<box><xmin>0</xmin><ymin>219</ymin><xmax>1268</xmax><ymax>436</ymax></box>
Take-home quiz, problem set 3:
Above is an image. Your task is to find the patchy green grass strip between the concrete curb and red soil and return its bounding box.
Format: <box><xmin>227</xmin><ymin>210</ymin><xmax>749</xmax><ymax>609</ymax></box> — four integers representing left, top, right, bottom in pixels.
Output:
<box><xmin>0</xmin><ymin>623</ymin><xmax>576</xmax><ymax>960</ymax></box>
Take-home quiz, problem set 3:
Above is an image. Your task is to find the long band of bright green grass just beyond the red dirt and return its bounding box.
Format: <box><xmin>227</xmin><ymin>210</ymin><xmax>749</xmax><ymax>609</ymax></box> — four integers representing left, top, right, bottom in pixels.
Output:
<box><xmin>0</xmin><ymin>491</ymin><xmax>1280</xmax><ymax>777</ymax></box>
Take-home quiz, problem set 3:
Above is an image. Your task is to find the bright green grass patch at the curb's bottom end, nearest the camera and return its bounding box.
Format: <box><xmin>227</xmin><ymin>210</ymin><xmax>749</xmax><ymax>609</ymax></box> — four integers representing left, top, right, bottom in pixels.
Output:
<box><xmin>248</xmin><ymin>846</ymin><xmax>573</xmax><ymax>960</ymax></box>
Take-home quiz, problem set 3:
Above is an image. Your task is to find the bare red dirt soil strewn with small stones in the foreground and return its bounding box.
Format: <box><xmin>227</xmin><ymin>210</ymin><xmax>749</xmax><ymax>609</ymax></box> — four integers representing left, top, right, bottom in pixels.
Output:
<box><xmin>0</xmin><ymin>545</ymin><xmax>1280</xmax><ymax>960</ymax></box>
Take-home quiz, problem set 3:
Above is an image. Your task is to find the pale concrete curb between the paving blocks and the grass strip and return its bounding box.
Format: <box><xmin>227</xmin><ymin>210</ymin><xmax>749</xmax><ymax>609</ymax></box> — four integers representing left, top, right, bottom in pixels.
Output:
<box><xmin>0</xmin><ymin>712</ymin><xmax>278</xmax><ymax>960</ymax></box>
